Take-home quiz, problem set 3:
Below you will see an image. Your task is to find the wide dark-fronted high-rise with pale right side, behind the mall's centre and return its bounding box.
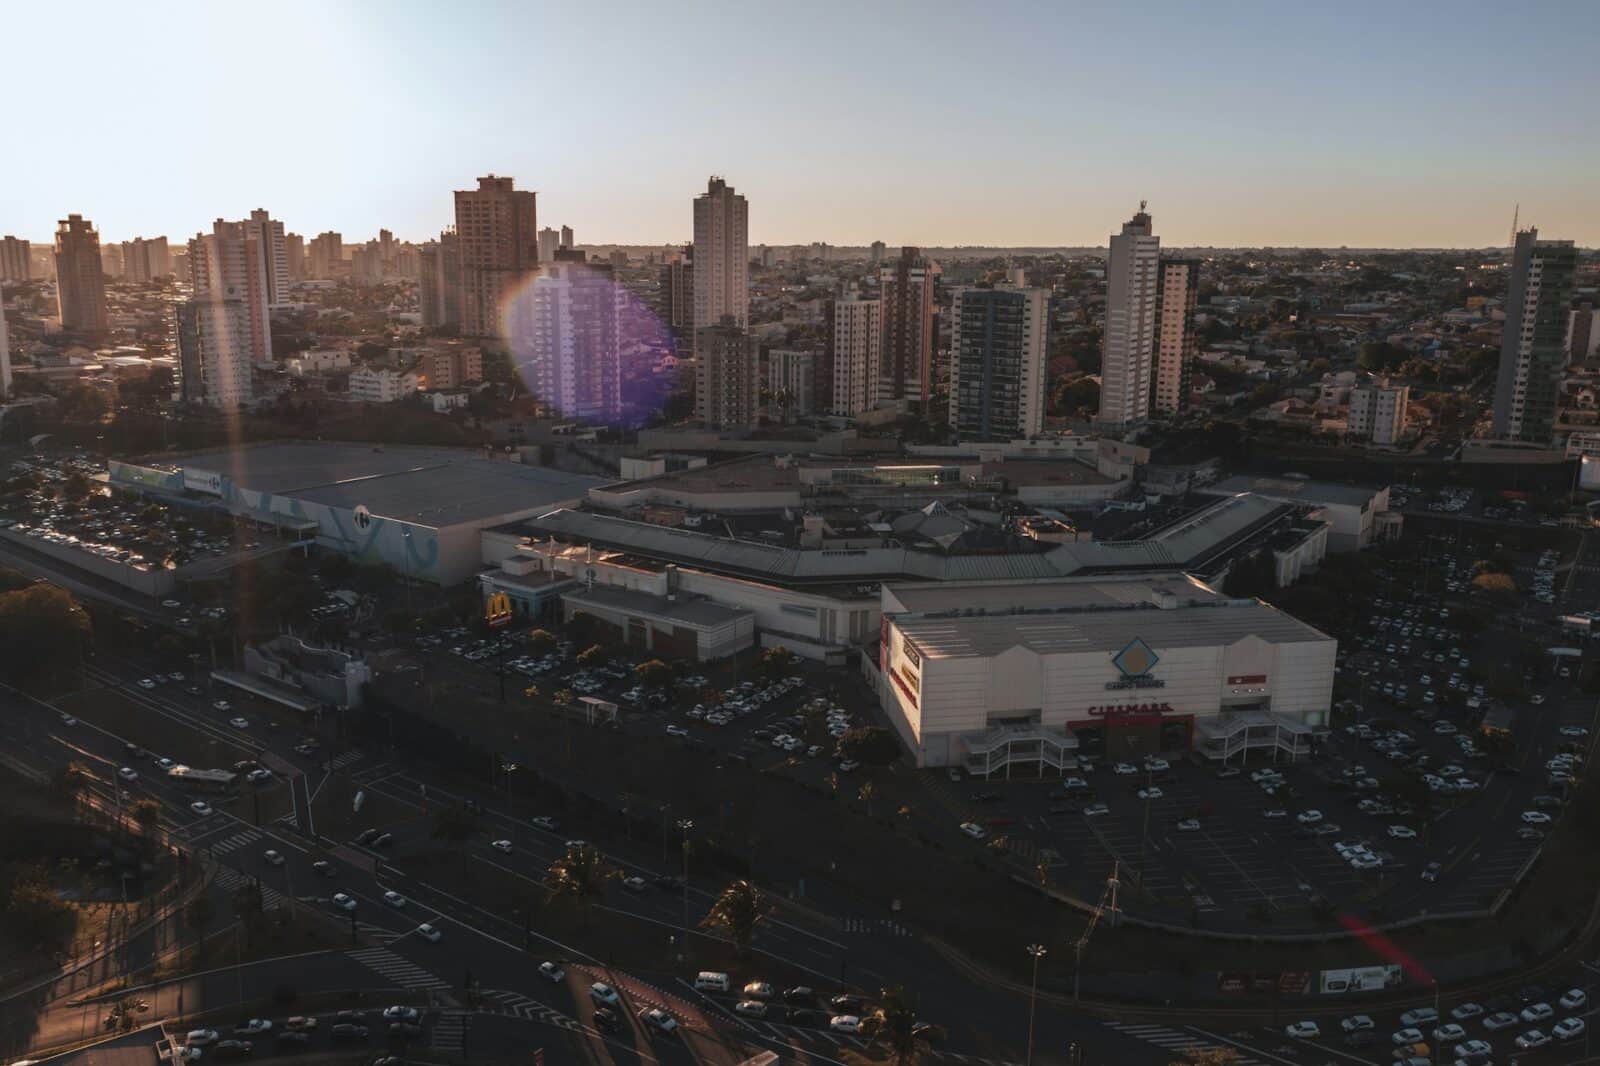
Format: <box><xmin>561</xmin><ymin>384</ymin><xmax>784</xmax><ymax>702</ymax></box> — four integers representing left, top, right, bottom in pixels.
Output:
<box><xmin>949</xmin><ymin>287</ymin><xmax>1050</xmax><ymax>442</ymax></box>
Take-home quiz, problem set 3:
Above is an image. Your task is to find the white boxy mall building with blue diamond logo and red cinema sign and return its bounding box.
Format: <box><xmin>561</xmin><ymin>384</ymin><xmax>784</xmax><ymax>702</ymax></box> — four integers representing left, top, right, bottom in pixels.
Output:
<box><xmin>864</xmin><ymin>575</ymin><xmax>1336</xmax><ymax>776</ymax></box>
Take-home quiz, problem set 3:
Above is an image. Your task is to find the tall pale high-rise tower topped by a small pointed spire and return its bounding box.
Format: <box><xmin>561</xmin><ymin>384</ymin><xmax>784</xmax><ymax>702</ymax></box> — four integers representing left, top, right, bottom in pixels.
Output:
<box><xmin>1098</xmin><ymin>202</ymin><xmax>1162</xmax><ymax>429</ymax></box>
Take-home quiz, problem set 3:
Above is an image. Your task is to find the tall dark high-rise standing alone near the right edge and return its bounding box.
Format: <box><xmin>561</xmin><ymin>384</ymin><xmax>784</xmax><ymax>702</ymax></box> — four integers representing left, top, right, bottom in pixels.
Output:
<box><xmin>1494</xmin><ymin>229</ymin><xmax>1578</xmax><ymax>443</ymax></box>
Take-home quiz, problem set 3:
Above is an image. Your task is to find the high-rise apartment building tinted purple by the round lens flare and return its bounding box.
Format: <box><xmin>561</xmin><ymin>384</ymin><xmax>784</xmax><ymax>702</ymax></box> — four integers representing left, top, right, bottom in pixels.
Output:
<box><xmin>506</xmin><ymin>262</ymin><xmax>624</xmax><ymax>423</ymax></box>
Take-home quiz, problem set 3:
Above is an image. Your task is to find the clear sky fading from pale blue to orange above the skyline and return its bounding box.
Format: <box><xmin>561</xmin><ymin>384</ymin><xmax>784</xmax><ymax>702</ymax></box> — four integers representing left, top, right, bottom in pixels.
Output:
<box><xmin>0</xmin><ymin>0</ymin><xmax>1600</xmax><ymax>246</ymax></box>
